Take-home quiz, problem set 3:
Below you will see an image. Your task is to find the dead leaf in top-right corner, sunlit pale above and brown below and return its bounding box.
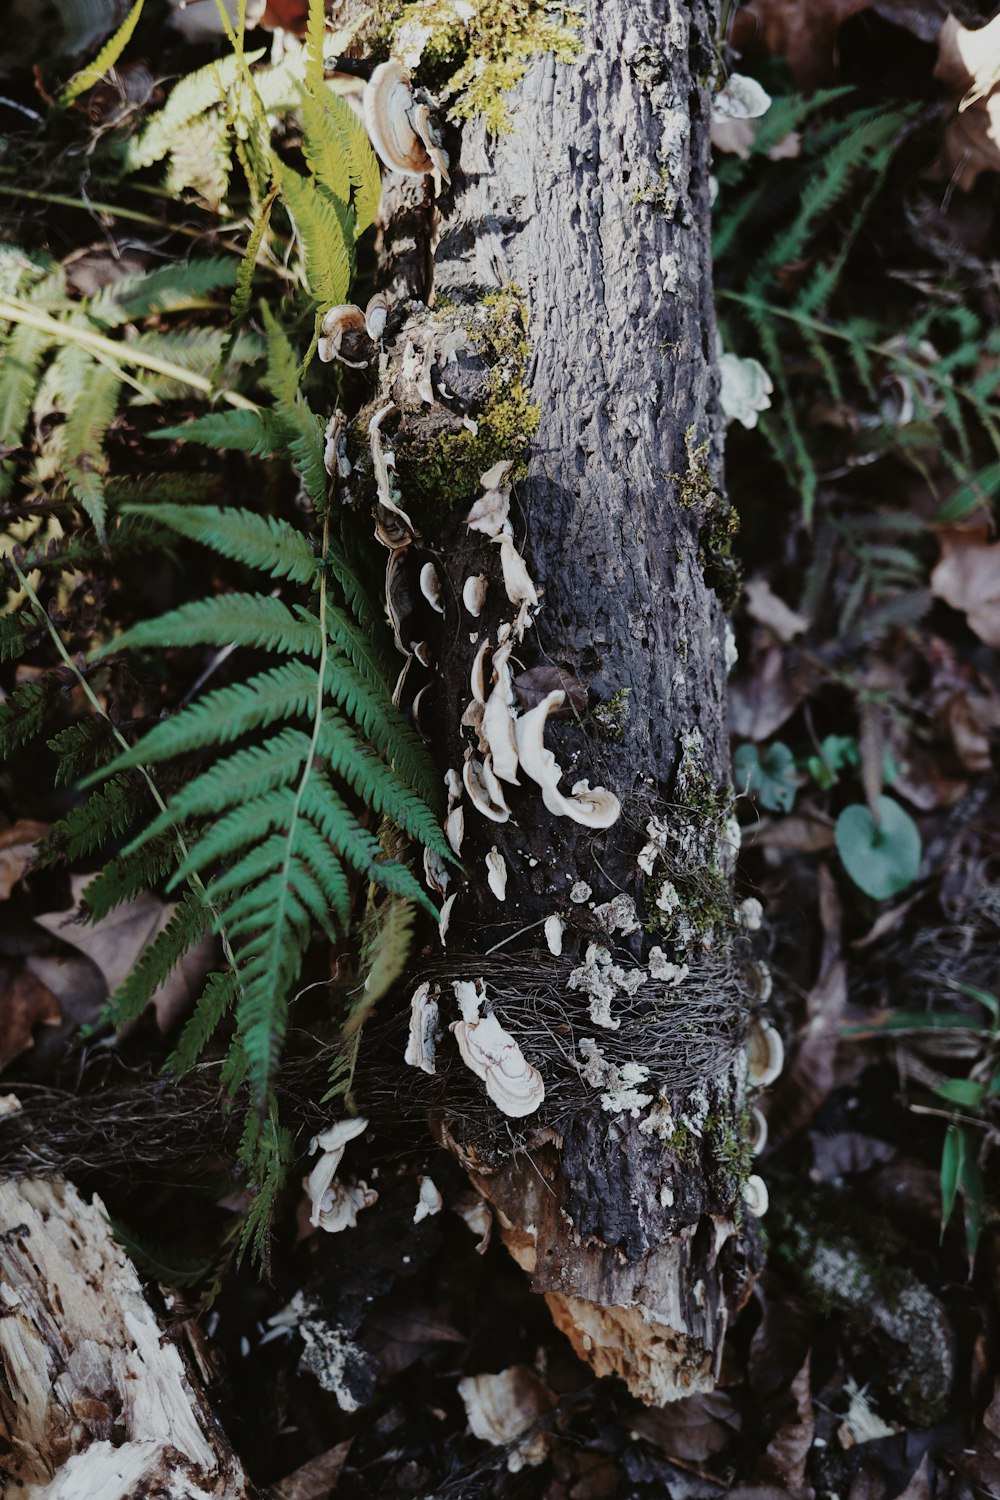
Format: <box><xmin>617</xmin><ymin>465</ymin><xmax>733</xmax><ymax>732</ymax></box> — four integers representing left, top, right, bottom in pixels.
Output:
<box><xmin>934</xmin><ymin>15</ymin><xmax>1000</xmax><ymax>192</ymax></box>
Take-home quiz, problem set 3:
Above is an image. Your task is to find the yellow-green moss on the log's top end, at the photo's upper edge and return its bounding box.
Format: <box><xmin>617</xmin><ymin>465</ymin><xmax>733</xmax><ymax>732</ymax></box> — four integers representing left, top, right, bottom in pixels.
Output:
<box><xmin>378</xmin><ymin>0</ymin><xmax>583</xmax><ymax>132</ymax></box>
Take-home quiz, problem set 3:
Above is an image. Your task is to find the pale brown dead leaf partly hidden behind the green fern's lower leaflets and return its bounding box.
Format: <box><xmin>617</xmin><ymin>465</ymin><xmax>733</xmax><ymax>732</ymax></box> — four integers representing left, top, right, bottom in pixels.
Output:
<box><xmin>34</xmin><ymin>875</ymin><xmax>216</xmax><ymax>1032</ymax></box>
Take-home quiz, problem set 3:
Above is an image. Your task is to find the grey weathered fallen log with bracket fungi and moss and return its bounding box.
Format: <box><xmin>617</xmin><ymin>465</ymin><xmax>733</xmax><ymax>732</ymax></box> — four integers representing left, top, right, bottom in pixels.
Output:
<box><xmin>371</xmin><ymin>0</ymin><xmax>759</xmax><ymax>1401</ymax></box>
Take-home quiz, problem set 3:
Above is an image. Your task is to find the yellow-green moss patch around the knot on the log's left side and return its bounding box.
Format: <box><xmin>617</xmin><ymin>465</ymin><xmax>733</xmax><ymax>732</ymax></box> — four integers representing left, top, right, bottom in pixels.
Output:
<box><xmin>396</xmin><ymin>287</ymin><xmax>541</xmax><ymax>525</ymax></box>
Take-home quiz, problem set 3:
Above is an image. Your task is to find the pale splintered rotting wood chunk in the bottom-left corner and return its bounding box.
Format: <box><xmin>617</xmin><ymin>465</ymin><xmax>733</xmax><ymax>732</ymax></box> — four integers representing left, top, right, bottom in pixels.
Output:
<box><xmin>0</xmin><ymin>1101</ymin><xmax>256</xmax><ymax>1500</ymax></box>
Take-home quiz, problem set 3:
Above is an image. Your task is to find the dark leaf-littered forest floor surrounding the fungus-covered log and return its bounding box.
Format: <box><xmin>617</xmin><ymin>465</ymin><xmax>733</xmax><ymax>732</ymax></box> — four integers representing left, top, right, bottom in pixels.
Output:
<box><xmin>0</xmin><ymin>0</ymin><xmax>1000</xmax><ymax>1500</ymax></box>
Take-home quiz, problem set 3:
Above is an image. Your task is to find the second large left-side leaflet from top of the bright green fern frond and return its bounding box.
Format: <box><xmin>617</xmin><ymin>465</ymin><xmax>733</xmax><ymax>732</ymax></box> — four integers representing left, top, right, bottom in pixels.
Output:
<box><xmin>91</xmin><ymin>594</ymin><xmax>321</xmax><ymax>662</ymax></box>
